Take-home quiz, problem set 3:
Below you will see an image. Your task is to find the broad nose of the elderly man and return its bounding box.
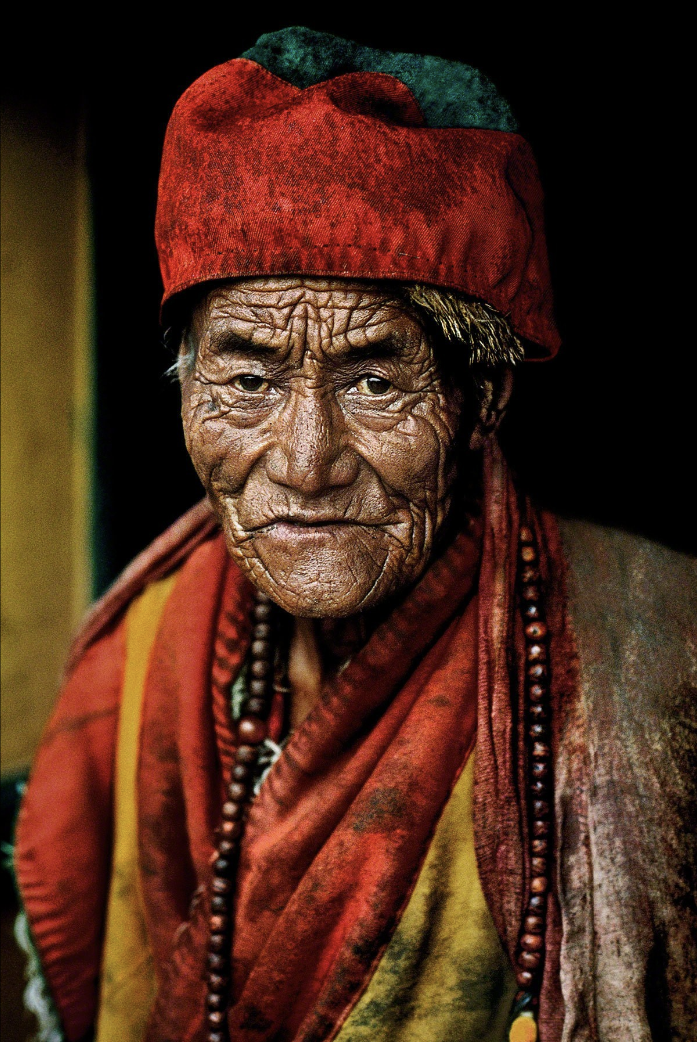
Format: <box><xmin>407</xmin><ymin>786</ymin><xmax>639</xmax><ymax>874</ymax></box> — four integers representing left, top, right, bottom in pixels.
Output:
<box><xmin>266</xmin><ymin>383</ymin><xmax>358</xmax><ymax>495</ymax></box>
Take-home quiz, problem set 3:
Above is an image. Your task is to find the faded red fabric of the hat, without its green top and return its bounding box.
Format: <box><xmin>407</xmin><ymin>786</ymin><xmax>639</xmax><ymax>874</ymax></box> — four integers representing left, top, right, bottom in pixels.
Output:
<box><xmin>155</xmin><ymin>58</ymin><xmax>559</xmax><ymax>355</ymax></box>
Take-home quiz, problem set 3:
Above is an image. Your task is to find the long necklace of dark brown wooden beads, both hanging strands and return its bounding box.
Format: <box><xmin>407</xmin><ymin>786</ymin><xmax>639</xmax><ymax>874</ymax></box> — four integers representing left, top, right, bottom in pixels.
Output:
<box><xmin>205</xmin><ymin>525</ymin><xmax>552</xmax><ymax>1042</ymax></box>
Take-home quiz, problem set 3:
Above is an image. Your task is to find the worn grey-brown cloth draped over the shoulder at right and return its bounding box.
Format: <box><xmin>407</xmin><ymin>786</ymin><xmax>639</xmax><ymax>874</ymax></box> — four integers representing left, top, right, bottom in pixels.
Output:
<box><xmin>555</xmin><ymin>521</ymin><xmax>697</xmax><ymax>1042</ymax></box>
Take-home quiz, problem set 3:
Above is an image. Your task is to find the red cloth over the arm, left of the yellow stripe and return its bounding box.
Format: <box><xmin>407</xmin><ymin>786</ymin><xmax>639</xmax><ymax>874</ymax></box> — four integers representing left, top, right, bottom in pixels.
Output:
<box><xmin>15</xmin><ymin>622</ymin><xmax>125</xmax><ymax>1042</ymax></box>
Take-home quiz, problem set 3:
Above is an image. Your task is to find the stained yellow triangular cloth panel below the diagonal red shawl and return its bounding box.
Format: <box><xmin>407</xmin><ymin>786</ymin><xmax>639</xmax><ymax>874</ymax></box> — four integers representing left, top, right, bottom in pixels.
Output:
<box><xmin>337</xmin><ymin>750</ymin><xmax>518</xmax><ymax>1042</ymax></box>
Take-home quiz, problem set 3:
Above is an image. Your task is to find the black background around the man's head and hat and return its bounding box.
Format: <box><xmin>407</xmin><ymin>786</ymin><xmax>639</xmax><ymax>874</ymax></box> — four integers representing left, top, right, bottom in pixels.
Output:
<box><xmin>4</xmin><ymin>10</ymin><xmax>696</xmax><ymax>590</ymax></box>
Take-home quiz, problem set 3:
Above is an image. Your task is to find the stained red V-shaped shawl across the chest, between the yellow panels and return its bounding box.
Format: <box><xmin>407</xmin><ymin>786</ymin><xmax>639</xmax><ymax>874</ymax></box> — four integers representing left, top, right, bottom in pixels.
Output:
<box><xmin>140</xmin><ymin>521</ymin><xmax>479</xmax><ymax>1042</ymax></box>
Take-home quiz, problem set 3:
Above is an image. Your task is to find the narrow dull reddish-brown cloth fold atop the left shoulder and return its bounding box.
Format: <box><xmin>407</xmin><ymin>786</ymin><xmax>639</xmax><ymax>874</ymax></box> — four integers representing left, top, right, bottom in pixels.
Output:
<box><xmin>66</xmin><ymin>499</ymin><xmax>218</xmax><ymax>674</ymax></box>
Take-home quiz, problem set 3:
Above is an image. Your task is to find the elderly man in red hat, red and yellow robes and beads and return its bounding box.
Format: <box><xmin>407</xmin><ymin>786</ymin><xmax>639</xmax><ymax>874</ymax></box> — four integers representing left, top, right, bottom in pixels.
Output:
<box><xmin>17</xmin><ymin>29</ymin><xmax>696</xmax><ymax>1042</ymax></box>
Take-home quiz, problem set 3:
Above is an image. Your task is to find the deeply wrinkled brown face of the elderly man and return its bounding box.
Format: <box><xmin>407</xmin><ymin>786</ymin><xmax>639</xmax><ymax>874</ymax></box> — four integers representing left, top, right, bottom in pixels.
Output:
<box><xmin>182</xmin><ymin>276</ymin><xmax>462</xmax><ymax>618</ymax></box>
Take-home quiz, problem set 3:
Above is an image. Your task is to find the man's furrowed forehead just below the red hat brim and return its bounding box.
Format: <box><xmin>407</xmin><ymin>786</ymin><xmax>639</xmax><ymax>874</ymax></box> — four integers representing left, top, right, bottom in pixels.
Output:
<box><xmin>195</xmin><ymin>276</ymin><xmax>423</xmax><ymax>348</ymax></box>
